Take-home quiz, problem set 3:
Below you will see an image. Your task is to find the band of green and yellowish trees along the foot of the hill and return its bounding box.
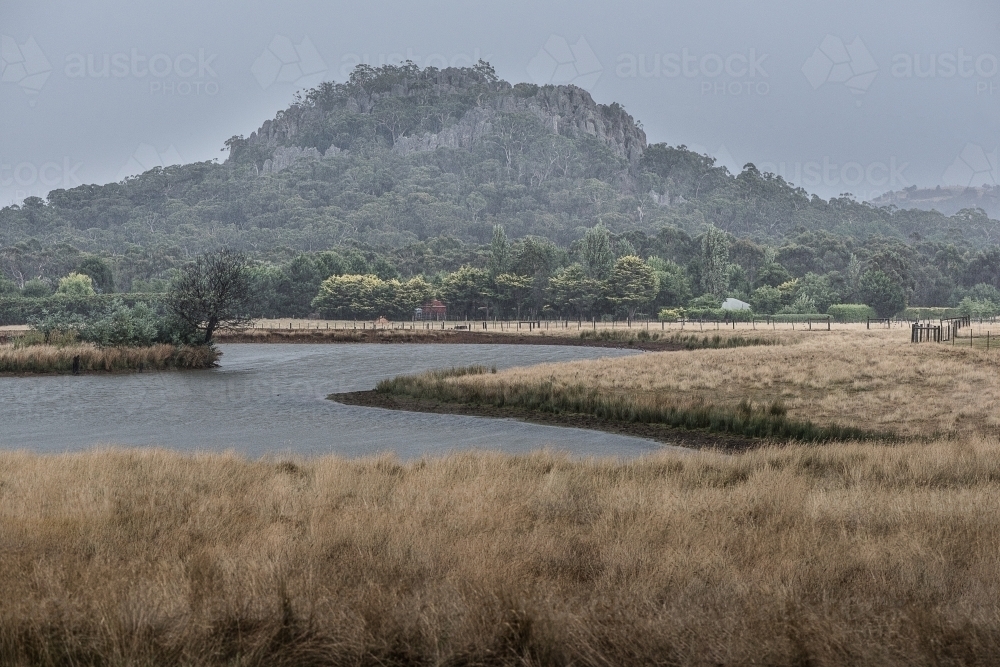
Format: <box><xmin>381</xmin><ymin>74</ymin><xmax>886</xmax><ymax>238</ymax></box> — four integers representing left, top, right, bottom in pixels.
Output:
<box><xmin>0</xmin><ymin>218</ymin><xmax>1000</xmax><ymax>319</ymax></box>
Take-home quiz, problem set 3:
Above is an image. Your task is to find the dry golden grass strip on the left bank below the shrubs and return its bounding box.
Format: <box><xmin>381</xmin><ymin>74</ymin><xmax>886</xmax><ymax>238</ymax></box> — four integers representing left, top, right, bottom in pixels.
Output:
<box><xmin>0</xmin><ymin>343</ymin><xmax>219</xmax><ymax>374</ymax></box>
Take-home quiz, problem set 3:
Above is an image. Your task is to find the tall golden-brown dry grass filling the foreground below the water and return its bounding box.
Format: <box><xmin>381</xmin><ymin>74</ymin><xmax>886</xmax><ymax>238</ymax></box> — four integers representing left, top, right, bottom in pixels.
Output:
<box><xmin>0</xmin><ymin>444</ymin><xmax>1000</xmax><ymax>666</ymax></box>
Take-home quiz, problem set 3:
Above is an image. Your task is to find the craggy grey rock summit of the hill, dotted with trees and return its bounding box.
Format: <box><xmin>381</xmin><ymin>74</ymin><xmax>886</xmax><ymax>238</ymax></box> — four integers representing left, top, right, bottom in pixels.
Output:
<box><xmin>230</xmin><ymin>63</ymin><xmax>646</xmax><ymax>173</ymax></box>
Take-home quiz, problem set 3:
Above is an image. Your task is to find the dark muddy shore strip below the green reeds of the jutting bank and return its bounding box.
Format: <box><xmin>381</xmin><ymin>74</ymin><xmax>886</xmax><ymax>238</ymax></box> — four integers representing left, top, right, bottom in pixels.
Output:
<box><xmin>327</xmin><ymin>390</ymin><xmax>756</xmax><ymax>453</ymax></box>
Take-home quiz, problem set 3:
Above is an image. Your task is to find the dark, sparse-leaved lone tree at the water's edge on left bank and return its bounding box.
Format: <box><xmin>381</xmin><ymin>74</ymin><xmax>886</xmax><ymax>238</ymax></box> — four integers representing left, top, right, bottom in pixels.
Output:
<box><xmin>167</xmin><ymin>250</ymin><xmax>252</xmax><ymax>345</ymax></box>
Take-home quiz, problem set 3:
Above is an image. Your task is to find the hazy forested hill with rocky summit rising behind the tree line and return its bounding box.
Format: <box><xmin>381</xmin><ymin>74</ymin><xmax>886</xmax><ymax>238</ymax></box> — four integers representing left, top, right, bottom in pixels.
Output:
<box><xmin>0</xmin><ymin>63</ymin><xmax>1000</xmax><ymax>303</ymax></box>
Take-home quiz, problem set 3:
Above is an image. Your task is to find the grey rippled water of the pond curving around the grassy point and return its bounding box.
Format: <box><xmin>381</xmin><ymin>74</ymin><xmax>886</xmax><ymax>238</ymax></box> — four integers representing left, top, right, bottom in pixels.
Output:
<box><xmin>0</xmin><ymin>345</ymin><xmax>676</xmax><ymax>458</ymax></box>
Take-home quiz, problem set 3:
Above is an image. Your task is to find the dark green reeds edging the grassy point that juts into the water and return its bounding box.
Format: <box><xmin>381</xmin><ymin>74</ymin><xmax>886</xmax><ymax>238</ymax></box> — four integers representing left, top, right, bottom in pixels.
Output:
<box><xmin>375</xmin><ymin>366</ymin><xmax>892</xmax><ymax>443</ymax></box>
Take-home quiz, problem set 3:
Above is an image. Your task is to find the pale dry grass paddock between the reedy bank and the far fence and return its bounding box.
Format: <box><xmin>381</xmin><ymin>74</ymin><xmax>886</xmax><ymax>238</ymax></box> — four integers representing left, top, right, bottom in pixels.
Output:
<box><xmin>449</xmin><ymin>329</ymin><xmax>1000</xmax><ymax>436</ymax></box>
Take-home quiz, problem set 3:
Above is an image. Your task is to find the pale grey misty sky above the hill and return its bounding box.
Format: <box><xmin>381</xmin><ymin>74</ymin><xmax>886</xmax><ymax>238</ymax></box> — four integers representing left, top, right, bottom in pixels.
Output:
<box><xmin>0</xmin><ymin>0</ymin><xmax>1000</xmax><ymax>205</ymax></box>
